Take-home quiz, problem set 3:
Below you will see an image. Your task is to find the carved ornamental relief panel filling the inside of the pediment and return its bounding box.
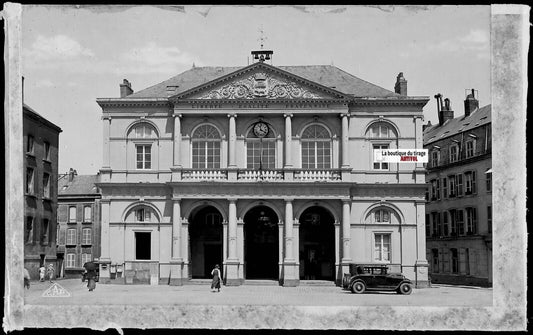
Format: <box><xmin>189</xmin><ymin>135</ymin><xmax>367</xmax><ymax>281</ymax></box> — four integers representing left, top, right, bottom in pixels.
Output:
<box><xmin>198</xmin><ymin>72</ymin><xmax>325</xmax><ymax>100</ymax></box>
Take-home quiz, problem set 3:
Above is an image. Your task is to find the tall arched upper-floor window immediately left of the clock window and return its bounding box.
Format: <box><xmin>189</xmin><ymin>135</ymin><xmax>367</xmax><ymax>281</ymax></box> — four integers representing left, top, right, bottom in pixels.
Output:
<box><xmin>192</xmin><ymin>124</ymin><xmax>221</xmax><ymax>169</ymax></box>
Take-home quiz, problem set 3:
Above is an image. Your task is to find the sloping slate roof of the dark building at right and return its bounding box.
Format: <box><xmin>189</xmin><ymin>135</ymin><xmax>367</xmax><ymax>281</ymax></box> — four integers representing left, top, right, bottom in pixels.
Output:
<box><xmin>424</xmin><ymin>105</ymin><xmax>491</xmax><ymax>145</ymax></box>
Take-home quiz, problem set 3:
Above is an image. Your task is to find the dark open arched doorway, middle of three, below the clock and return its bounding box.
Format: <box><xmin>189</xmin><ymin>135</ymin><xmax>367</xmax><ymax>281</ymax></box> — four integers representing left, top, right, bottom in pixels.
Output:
<box><xmin>244</xmin><ymin>206</ymin><xmax>279</xmax><ymax>280</ymax></box>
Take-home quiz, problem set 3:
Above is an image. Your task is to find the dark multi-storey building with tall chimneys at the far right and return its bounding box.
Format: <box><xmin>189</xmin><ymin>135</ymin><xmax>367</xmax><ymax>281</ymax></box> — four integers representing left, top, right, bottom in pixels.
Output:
<box><xmin>424</xmin><ymin>90</ymin><xmax>492</xmax><ymax>286</ymax></box>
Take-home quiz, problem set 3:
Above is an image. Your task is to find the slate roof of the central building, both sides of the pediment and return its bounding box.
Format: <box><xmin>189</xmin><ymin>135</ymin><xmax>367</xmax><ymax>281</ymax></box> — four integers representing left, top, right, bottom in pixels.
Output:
<box><xmin>126</xmin><ymin>65</ymin><xmax>400</xmax><ymax>98</ymax></box>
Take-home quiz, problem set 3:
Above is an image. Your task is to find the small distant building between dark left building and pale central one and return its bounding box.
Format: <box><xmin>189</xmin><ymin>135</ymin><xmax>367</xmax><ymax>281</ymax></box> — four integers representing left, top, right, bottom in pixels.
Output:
<box><xmin>57</xmin><ymin>169</ymin><xmax>101</xmax><ymax>278</ymax></box>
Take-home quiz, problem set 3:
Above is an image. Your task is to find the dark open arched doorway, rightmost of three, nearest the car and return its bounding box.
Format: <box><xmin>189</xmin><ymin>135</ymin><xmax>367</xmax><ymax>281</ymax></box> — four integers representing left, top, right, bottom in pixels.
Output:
<box><xmin>299</xmin><ymin>206</ymin><xmax>335</xmax><ymax>280</ymax></box>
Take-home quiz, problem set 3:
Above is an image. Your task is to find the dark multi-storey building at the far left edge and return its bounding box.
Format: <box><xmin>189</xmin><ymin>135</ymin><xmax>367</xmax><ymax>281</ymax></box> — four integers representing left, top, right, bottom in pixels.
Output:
<box><xmin>22</xmin><ymin>103</ymin><xmax>62</xmax><ymax>279</ymax></box>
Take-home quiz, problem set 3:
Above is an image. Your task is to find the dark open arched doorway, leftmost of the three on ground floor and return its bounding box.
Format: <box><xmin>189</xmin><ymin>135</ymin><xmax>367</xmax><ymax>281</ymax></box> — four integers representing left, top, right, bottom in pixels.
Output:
<box><xmin>189</xmin><ymin>206</ymin><xmax>223</xmax><ymax>278</ymax></box>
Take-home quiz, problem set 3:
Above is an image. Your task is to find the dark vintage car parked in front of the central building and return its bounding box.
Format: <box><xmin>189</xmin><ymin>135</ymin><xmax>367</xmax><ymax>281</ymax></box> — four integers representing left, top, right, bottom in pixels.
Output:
<box><xmin>342</xmin><ymin>264</ymin><xmax>413</xmax><ymax>294</ymax></box>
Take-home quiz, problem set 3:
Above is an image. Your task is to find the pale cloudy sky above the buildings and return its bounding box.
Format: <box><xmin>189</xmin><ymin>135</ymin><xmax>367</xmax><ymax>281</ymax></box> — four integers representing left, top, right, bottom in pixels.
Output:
<box><xmin>22</xmin><ymin>5</ymin><xmax>491</xmax><ymax>174</ymax></box>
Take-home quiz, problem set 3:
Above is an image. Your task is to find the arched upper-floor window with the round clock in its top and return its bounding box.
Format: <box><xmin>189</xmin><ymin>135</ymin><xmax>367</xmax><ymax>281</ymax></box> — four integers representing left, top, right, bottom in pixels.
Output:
<box><xmin>246</xmin><ymin>122</ymin><xmax>276</xmax><ymax>170</ymax></box>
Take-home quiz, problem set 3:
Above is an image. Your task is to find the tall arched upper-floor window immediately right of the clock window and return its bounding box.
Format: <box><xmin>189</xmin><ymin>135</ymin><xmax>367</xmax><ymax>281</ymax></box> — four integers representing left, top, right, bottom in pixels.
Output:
<box><xmin>302</xmin><ymin>124</ymin><xmax>331</xmax><ymax>169</ymax></box>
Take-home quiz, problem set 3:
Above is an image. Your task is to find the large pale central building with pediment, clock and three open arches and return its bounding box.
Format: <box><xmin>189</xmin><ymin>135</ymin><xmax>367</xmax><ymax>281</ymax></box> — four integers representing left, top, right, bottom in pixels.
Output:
<box><xmin>97</xmin><ymin>50</ymin><xmax>429</xmax><ymax>286</ymax></box>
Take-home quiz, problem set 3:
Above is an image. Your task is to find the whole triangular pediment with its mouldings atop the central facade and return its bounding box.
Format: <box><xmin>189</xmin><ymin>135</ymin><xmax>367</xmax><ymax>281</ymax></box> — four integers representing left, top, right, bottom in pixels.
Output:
<box><xmin>171</xmin><ymin>63</ymin><xmax>346</xmax><ymax>100</ymax></box>
